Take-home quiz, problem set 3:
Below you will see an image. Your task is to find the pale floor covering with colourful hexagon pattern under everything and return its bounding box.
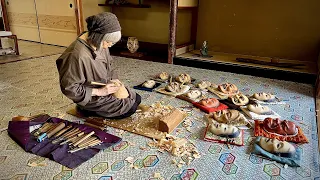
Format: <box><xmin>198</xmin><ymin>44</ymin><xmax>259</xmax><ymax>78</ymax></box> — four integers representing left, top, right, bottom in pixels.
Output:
<box><xmin>0</xmin><ymin>55</ymin><xmax>320</xmax><ymax>180</ymax></box>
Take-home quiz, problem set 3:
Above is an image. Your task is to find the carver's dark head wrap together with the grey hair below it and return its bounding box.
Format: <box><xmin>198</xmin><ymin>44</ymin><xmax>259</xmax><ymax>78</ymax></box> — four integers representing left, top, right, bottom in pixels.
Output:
<box><xmin>86</xmin><ymin>12</ymin><xmax>121</xmax><ymax>47</ymax></box>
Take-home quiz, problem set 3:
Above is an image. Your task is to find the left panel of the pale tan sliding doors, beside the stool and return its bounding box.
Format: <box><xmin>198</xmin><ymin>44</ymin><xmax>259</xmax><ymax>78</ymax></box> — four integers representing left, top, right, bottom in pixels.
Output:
<box><xmin>6</xmin><ymin>0</ymin><xmax>40</xmax><ymax>42</ymax></box>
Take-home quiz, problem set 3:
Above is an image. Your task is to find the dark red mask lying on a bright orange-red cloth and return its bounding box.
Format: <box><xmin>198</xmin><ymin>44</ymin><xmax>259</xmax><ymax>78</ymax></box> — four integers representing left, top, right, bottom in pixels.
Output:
<box><xmin>263</xmin><ymin>118</ymin><xmax>298</xmax><ymax>136</ymax></box>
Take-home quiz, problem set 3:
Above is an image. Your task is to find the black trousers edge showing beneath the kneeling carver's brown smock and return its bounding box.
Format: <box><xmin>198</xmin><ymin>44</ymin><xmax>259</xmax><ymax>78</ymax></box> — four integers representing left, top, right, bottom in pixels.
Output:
<box><xmin>77</xmin><ymin>94</ymin><xmax>141</xmax><ymax>119</ymax></box>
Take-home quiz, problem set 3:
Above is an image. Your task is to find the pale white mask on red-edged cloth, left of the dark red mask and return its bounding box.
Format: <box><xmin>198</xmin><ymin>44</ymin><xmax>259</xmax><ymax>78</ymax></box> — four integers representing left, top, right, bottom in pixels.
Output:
<box><xmin>209</xmin><ymin>121</ymin><xmax>240</xmax><ymax>138</ymax></box>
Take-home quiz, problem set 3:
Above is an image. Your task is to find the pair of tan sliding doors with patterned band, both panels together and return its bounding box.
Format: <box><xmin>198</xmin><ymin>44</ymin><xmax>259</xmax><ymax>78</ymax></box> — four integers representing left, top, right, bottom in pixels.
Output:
<box><xmin>5</xmin><ymin>0</ymin><xmax>82</xmax><ymax>46</ymax></box>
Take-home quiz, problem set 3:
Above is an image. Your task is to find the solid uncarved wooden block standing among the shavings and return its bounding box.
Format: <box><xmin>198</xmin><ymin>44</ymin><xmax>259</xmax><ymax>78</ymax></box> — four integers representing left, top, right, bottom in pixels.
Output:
<box><xmin>159</xmin><ymin>109</ymin><xmax>185</xmax><ymax>133</ymax></box>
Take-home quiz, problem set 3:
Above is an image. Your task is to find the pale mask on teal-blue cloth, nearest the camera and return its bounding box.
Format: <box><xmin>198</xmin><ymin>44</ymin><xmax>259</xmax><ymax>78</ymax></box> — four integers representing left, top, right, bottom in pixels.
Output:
<box><xmin>259</xmin><ymin>137</ymin><xmax>296</xmax><ymax>157</ymax></box>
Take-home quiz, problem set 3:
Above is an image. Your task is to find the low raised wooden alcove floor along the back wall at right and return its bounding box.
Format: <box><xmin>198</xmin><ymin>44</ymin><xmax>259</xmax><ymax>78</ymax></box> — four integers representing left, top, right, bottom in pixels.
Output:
<box><xmin>177</xmin><ymin>50</ymin><xmax>317</xmax><ymax>74</ymax></box>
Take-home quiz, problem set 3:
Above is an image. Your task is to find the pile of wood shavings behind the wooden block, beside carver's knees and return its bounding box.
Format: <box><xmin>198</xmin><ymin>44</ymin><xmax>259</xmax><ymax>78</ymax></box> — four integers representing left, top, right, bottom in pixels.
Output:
<box><xmin>132</xmin><ymin>102</ymin><xmax>174</xmax><ymax>121</ymax></box>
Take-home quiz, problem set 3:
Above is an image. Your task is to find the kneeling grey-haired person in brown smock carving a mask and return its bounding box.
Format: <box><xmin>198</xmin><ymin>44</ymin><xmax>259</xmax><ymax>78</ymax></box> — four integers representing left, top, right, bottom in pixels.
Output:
<box><xmin>56</xmin><ymin>12</ymin><xmax>141</xmax><ymax>119</ymax></box>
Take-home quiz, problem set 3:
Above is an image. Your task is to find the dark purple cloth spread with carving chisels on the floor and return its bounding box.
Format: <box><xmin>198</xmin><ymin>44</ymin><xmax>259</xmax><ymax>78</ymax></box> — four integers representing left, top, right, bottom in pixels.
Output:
<box><xmin>8</xmin><ymin>114</ymin><xmax>121</xmax><ymax>169</ymax></box>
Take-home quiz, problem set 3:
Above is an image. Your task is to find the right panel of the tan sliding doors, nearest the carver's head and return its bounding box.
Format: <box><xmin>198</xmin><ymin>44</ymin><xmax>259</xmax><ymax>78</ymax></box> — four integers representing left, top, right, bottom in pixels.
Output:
<box><xmin>35</xmin><ymin>0</ymin><xmax>77</xmax><ymax>46</ymax></box>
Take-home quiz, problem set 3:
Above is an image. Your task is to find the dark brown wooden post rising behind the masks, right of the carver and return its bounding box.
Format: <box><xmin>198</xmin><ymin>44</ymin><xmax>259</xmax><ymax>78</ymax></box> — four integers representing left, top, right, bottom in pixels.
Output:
<box><xmin>168</xmin><ymin>0</ymin><xmax>178</xmax><ymax>64</ymax></box>
